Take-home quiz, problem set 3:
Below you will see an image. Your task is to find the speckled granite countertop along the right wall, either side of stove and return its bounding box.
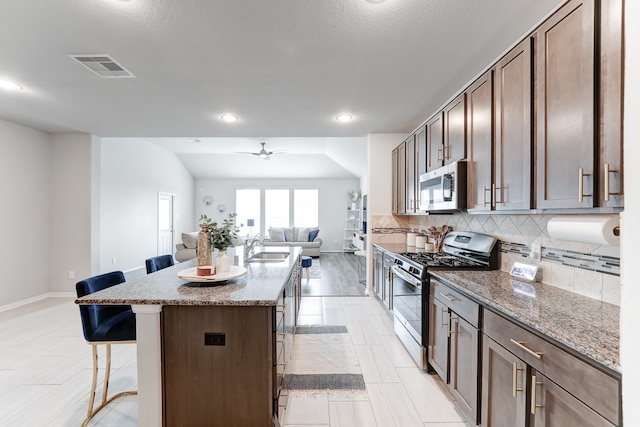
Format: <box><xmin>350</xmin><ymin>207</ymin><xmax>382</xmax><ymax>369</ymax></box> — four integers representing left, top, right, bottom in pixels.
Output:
<box><xmin>376</xmin><ymin>244</ymin><xmax>622</xmax><ymax>373</ymax></box>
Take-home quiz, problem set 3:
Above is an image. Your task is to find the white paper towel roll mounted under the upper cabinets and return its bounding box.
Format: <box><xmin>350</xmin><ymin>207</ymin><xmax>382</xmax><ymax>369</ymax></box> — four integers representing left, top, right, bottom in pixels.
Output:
<box><xmin>547</xmin><ymin>215</ymin><xmax>620</xmax><ymax>246</ymax></box>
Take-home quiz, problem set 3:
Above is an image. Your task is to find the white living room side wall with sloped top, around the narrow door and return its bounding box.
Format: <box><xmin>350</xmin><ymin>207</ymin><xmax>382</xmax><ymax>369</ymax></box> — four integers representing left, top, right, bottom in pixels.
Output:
<box><xmin>100</xmin><ymin>138</ymin><xmax>195</xmax><ymax>272</ymax></box>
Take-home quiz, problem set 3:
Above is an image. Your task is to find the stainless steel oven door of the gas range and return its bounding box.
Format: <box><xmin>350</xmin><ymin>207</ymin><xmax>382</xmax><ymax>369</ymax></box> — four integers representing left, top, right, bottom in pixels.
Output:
<box><xmin>391</xmin><ymin>265</ymin><xmax>427</xmax><ymax>369</ymax></box>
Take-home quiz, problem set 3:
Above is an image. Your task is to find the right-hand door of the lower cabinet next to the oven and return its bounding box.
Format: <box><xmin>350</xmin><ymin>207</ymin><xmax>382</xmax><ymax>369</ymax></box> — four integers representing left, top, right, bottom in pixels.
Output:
<box><xmin>449</xmin><ymin>313</ymin><xmax>479</xmax><ymax>423</ymax></box>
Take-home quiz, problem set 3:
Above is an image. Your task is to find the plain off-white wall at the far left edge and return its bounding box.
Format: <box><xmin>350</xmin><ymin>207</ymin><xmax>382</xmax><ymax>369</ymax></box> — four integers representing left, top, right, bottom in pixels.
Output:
<box><xmin>0</xmin><ymin>120</ymin><xmax>51</xmax><ymax>307</ymax></box>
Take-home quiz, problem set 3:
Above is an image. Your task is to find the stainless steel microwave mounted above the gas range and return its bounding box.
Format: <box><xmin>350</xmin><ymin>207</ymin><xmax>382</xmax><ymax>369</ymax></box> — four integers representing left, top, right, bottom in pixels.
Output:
<box><xmin>419</xmin><ymin>161</ymin><xmax>467</xmax><ymax>212</ymax></box>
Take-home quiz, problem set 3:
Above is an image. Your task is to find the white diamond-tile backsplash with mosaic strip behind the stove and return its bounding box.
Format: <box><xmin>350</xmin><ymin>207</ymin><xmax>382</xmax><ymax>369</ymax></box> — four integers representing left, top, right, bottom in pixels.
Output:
<box><xmin>371</xmin><ymin>214</ymin><xmax>621</xmax><ymax>306</ymax></box>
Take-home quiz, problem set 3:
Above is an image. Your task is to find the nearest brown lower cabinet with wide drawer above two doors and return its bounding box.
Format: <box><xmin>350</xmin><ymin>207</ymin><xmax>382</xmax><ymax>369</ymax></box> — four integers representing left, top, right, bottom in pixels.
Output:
<box><xmin>481</xmin><ymin>309</ymin><xmax>622</xmax><ymax>427</ymax></box>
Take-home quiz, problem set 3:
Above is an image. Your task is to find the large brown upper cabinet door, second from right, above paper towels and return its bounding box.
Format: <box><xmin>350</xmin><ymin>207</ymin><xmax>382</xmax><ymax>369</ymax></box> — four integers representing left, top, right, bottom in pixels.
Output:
<box><xmin>536</xmin><ymin>0</ymin><xmax>597</xmax><ymax>209</ymax></box>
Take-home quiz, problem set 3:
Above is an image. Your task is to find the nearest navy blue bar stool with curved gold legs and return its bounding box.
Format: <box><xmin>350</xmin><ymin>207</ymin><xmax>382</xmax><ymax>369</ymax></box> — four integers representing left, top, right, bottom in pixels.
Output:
<box><xmin>76</xmin><ymin>271</ymin><xmax>138</xmax><ymax>427</ymax></box>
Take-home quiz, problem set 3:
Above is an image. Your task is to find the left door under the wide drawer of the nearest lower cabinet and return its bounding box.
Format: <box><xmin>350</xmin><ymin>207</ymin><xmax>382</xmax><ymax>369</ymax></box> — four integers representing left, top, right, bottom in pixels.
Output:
<box><xmin>480</xmin><ymin>335</ymin><xmax>528</xmax><ymax>427</ymax></box>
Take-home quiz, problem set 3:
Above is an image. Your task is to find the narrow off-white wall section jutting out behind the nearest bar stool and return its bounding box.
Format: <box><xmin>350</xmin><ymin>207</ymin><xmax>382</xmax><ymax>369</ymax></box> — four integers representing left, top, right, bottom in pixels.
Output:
<box><xmin>49</xmin><ymin>133</ymin><xmax>98</xmax><ymax>293</ymax></box>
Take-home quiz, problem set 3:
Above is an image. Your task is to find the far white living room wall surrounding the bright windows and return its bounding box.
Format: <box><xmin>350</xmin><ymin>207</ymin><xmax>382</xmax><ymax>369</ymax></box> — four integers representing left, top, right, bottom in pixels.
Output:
<box><xmin>195</xmin><ymin>178</ymin><xmax>360</xmax><ymax>252</ymax></box>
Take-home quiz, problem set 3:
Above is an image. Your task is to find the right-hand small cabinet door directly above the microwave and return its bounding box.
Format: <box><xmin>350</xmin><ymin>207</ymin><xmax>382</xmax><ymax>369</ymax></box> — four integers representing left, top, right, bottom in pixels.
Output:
<box><xmin>442</xmin><ymin>93</ymin><xmax>467</xmax><ymax>165</ymax></box>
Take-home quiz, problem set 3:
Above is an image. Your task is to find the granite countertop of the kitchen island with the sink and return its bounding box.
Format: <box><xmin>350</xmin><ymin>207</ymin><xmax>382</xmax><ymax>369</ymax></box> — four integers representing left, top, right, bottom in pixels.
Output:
<box><xmin>76</xmin><ymin>246</ymin><xmax>302</xmax><ymax>306</ymax></box>
